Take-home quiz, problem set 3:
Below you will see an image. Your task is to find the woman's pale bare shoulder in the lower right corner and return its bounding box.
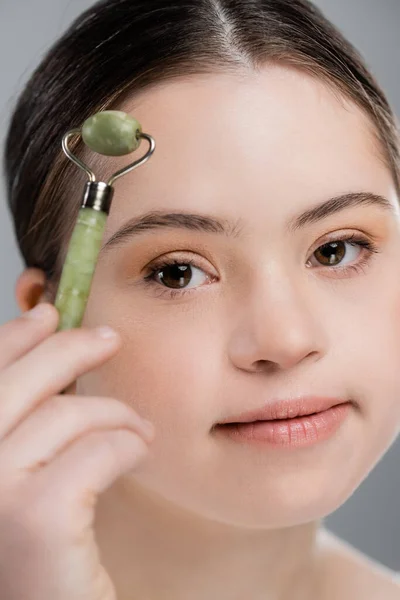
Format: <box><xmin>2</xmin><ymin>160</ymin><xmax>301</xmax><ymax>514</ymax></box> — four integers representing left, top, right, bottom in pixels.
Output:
<box><xmin>319</xmin><ymin>529</ymin><xmax>400</xmax><ymax>600</ymax></box>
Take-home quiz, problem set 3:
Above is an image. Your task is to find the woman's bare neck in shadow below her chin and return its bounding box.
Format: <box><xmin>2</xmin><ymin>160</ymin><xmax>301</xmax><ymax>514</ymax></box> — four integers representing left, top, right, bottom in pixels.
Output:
<box><xmin>95</xmin><ymin>478</ymin><xmax>321</xmax><ymax>600</ymax></box>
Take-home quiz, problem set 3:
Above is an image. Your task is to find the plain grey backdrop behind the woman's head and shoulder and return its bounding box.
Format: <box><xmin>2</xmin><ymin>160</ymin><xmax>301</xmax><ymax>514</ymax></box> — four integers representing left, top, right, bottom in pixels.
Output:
<box><xmin>0</xmin><ymin>0</ymin><xmax>400</xmax><ymax>571</ymax></box>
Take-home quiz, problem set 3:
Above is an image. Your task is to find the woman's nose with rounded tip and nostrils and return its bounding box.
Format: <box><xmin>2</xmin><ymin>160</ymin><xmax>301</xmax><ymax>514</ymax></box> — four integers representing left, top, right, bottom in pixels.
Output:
<box><xmin>229</xmin><ymin>272</ymin><xmax>326</xmax><ymax>372</ymax></box>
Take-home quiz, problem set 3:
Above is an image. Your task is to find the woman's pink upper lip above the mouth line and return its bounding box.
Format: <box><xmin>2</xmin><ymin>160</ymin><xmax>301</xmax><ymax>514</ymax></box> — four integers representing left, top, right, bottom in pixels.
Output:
<box><xmin>219</xmin><ymin>396</ymin><xmax>348</xmax><ymax>425</ymax></box>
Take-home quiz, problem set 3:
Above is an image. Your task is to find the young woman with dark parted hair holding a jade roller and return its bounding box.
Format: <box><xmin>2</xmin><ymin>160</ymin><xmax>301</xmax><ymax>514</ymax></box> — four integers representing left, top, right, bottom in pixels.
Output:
<box><xmin>0</xmin><ymin>0</ymin><xmax>400</xmax><ymax>600</ymax></box>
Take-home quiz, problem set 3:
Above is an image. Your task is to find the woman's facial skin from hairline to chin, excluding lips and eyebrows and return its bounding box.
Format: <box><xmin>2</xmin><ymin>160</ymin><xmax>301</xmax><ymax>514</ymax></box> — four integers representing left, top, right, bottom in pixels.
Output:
<box><xmin>76</xmin><ymin>66</ymin><xmax>400</xmax><ymax>527</ymax></box>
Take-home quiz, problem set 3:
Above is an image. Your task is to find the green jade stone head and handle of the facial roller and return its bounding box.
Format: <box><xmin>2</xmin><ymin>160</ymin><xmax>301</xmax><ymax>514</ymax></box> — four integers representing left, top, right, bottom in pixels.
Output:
<box><xmin>54</xmin><ymin>110</ymin><xmax>141</xmax><ymax>331</ymax></box>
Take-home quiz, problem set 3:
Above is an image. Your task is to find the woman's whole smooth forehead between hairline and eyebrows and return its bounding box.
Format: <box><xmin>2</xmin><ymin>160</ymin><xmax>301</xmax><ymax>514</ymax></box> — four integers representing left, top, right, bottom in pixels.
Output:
<box><xmin>95</xmin><ymin>65</ymin><xmax>390</xmax><ymax>229</ymax></box>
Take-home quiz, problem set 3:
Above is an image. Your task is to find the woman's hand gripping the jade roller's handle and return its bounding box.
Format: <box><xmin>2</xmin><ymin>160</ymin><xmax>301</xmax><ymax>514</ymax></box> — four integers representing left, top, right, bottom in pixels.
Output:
<box><xmin>0</xmin><ymin>303</ymin><xmax>153</xmax><ymax>600</ymax></box>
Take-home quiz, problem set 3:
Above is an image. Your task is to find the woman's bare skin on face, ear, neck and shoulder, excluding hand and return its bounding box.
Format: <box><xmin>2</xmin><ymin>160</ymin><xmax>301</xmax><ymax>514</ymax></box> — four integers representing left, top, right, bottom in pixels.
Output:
<box><xmin>13</xmin><ymin>66</ymin><xmax>400</xmax><ymax>600</ymax></box>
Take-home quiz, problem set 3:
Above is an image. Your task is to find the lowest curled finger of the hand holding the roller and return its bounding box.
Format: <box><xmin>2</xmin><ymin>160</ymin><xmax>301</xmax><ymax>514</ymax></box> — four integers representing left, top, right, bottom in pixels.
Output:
<box><xmin>25</xmin><ymin>429</ymin><xmax>149</xmax><ymax>539</ymax></box>
